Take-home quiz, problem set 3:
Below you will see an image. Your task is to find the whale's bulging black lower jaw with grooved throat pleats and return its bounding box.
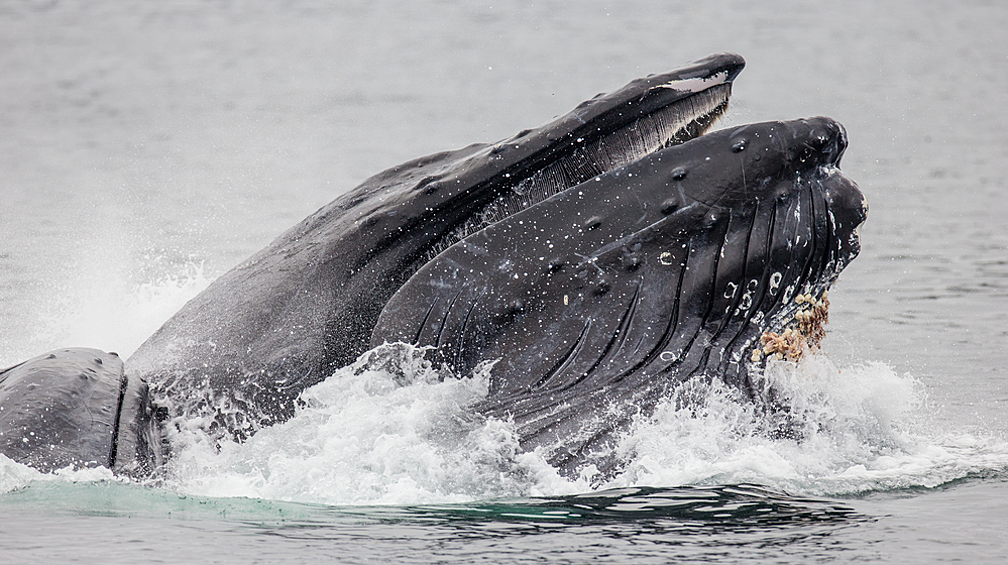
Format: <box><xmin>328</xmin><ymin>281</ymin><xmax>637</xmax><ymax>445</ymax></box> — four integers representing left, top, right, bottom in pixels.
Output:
<box><xmin>371</xmin><ymin>118</ymin><xmax>865</xmax><ymax>473</ymax></box>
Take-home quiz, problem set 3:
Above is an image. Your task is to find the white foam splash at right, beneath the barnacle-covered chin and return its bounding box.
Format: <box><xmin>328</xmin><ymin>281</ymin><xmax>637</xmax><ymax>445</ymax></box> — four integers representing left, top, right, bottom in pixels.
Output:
<box><xmin>612</xmin><ymin>355</ymin><xmax>1008</xmax><ymax>496</ymax></box>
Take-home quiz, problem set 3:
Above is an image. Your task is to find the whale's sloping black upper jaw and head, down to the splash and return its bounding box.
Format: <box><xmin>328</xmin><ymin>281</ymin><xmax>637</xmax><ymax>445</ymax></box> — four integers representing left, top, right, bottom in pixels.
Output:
<box><xmin>126</xmin><ymin>54</ymin><xmax>744</xmax><ymax>437</ymax></box>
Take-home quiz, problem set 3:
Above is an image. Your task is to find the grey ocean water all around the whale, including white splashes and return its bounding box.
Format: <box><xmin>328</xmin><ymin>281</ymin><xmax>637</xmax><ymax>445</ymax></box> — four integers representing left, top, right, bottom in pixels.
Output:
<box><xmin>0</xmin><ymin>0</ymin><xmax>1008</xmax><ymax>564</ymax></box>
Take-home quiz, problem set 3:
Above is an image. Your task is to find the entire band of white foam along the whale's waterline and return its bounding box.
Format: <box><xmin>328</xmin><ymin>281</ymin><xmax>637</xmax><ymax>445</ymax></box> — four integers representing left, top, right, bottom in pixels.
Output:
<box><xmin>0</xmin><ymin>344</ymin><xmax>1008</xmax><ymax>505</ymax></box>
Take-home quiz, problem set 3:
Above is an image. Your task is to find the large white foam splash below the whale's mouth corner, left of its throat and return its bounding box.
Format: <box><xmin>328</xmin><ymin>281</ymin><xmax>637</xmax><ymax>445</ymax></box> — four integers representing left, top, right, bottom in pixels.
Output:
<box><xmin>160</xmin><ymin>343</ymin><xmax>585</xmax><ymax>505</ymax></box>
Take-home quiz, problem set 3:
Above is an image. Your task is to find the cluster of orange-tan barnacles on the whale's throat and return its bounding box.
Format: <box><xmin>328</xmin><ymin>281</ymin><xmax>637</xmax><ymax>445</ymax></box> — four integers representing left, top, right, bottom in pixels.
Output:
<box><xmin>752</xmin><ymin>290</ymin><xmax>830</xmax><ymax>363</ymax></box>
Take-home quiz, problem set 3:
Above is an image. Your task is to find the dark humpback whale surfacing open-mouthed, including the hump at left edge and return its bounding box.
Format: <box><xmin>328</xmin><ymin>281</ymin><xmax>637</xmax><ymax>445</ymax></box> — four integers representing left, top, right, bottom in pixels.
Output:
<box><xmin>0</xmin><ymin>53</ymin><xmax>867</xmax><ymax>474</ymax></box>
